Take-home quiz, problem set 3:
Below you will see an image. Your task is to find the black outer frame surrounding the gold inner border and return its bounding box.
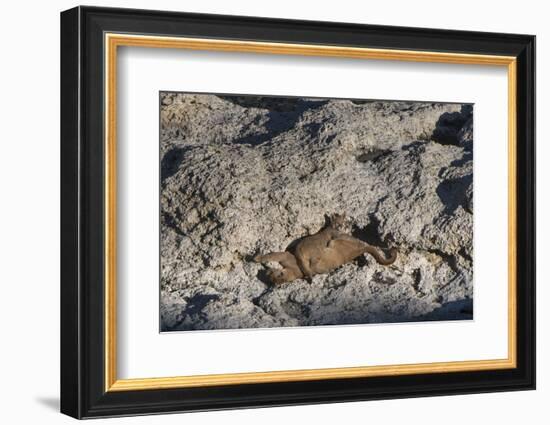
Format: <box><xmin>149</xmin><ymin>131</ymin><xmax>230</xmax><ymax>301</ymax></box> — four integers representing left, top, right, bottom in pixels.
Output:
<box><xmin>61</xmin><ymin>7</ymin><xmax>535</xmax><ymax>418</ymax></box>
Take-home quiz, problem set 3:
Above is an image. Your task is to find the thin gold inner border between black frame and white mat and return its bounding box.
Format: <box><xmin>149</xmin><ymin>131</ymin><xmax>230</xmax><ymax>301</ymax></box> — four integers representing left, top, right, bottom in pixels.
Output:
<box><xmin>104</xmin><ymin>33</ymin><xmax>517</xmax><ymax>392</ymax></box>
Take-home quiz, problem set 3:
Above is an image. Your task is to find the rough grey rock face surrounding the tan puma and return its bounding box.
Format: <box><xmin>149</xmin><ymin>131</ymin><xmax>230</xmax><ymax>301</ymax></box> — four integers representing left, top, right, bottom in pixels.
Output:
<box><xmin>160</xmin><ymin>93</ymin><xmax>473</xmax><ymax>331</ymax></box>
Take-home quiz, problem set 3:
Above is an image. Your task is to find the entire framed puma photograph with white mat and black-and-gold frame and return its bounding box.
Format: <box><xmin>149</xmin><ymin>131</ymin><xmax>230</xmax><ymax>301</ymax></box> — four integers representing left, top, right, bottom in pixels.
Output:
<box><xmin>61</xmin><ymin>7</ymin><xmax>535</xmax><ymax>418</ymax></box>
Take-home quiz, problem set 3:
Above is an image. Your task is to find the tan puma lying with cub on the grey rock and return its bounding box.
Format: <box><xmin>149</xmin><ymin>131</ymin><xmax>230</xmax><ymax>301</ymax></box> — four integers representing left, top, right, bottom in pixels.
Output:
<box><xmin>254</xmin><ymin>215</ymin><xmax>397</xmax><ymax>284</ymax></box>
